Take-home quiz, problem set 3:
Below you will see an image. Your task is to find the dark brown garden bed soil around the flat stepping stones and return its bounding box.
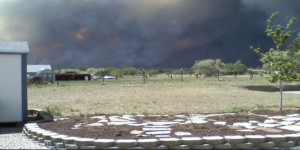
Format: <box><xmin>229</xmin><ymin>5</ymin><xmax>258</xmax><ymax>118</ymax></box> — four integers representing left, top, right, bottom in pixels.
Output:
<box><xmin>38</xmin><ymin>109</ymin><xmax>300</xmax><ymax>139</ymax></box>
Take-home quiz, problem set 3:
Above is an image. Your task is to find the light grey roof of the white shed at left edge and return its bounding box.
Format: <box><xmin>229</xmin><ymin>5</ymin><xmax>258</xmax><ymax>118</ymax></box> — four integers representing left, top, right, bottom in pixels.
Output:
<box><xmin>0</xmin><ymin>41</ymin><xmax>29</xmax><ymax>53</ymax></box>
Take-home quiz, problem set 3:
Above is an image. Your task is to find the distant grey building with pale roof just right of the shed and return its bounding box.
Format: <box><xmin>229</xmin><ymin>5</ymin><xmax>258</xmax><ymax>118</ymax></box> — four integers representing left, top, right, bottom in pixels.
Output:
<box><xmin>27</xmin><ymin>65</ymin><xmax>55</xmax><ymax>82</ymax></box>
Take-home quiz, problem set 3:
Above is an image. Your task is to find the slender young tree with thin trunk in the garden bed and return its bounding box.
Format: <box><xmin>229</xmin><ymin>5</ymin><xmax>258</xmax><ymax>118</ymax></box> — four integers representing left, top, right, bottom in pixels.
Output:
<box><xmin>255</xmin><ymin>12</ymin><xmax>300</xmax><ymax>111</ymax></box>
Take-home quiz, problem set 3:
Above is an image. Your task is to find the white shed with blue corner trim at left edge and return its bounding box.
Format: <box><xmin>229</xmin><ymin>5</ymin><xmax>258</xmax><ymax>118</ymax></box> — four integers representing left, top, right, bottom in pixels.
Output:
<box><xmin>0</xmin><ymin>41</ymin><xmax>29</xmax><ymax>123</ymax></box>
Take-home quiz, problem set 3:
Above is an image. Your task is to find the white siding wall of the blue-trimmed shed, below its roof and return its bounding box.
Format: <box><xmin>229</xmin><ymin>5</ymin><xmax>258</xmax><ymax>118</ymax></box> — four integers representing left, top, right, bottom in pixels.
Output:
<box><xmin>0</xmin><ymin>54</ymin><xmax>22</xmax><ymax>122</ymax></box>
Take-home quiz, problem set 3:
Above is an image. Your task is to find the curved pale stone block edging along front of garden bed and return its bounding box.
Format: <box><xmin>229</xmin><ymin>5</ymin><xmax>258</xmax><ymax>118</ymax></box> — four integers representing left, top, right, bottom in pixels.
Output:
<box><xmin>23</xmin><ymin>113</ymin><xmax>300</xmax><ymax>149</ymax></box>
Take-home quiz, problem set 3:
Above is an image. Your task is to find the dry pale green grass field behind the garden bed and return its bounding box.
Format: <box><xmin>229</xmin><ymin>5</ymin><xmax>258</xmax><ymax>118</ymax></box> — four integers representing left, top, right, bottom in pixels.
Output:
<box><xmin>28</xmin><ymin>75</ymin><xmax>300</xmax><ymax>116</ymax></box>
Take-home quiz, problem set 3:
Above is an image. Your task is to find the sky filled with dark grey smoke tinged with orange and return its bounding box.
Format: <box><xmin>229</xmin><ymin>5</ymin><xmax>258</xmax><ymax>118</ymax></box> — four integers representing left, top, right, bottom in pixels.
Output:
<box><xmin>0</xmin><ymin>0</ymin><xmax>300</xmax><ymax>68</ymax></box>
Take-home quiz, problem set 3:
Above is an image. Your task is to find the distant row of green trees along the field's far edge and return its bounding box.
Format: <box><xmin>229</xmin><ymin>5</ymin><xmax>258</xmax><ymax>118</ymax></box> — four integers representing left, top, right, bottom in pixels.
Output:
<box><xmin>55</xmin><ymin>59</ymin><xmax>248</xmax><ymax>78</ymax></box>
